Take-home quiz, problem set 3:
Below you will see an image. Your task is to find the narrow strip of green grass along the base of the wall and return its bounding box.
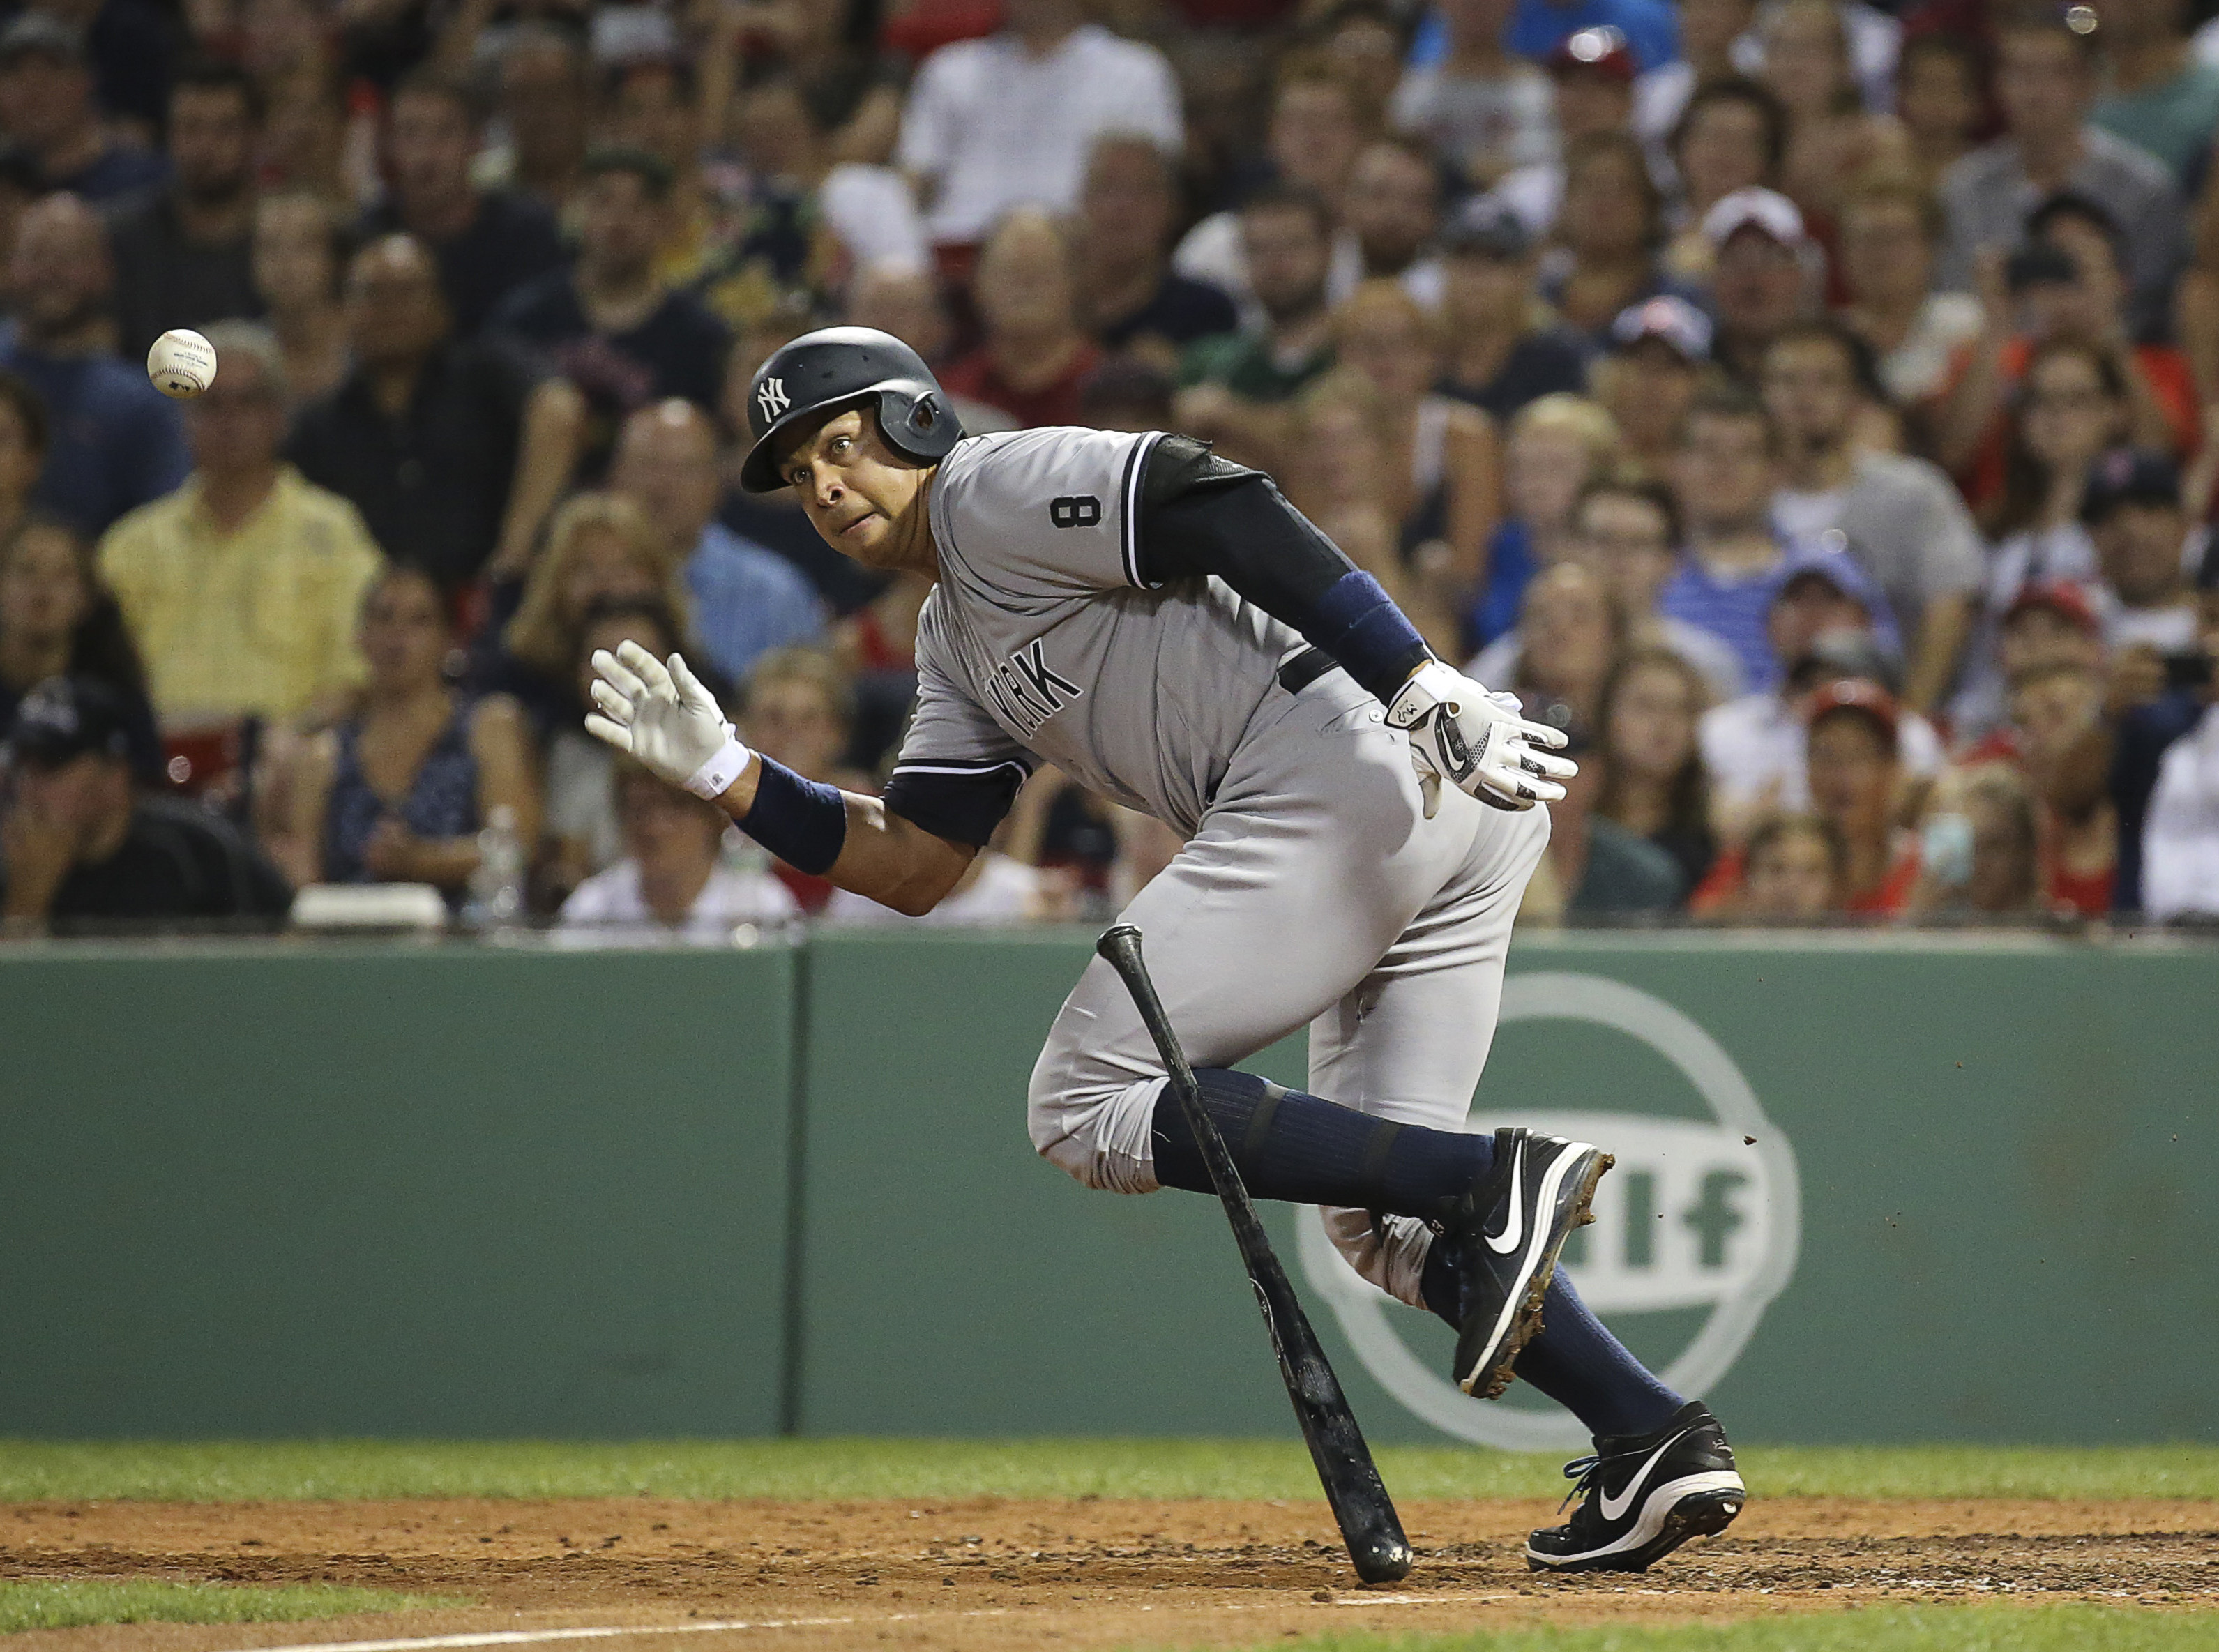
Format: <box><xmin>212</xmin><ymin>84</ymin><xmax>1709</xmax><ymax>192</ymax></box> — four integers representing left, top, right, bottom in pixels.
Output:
<box><xmin>0</xmin><ymin>1439</ymin><xmax>2219</xmax><ymax>1503</ymax></box>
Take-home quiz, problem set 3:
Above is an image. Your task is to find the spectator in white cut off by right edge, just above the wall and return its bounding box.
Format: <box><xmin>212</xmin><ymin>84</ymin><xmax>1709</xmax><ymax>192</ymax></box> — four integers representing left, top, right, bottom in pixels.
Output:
<box><xmin>2112</xmin><ymin>583</ymin><xmax>2219</xmax><ymax>920</ymax></box>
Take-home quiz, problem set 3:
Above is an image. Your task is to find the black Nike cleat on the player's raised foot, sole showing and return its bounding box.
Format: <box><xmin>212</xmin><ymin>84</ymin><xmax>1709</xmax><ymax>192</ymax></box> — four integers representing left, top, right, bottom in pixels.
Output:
<box><xmin>1434</xmin><ymin>1129</ymin><xmax>1611</xmax><ymax>1399</ymax></box>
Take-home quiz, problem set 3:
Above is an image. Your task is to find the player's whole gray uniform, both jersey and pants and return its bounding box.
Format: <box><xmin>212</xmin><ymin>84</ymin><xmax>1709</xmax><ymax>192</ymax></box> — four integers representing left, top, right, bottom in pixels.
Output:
<box><xmin>888</xmin><ymin>428</ymin><xmax>1549</xmax><ymax>1304</ymax></box>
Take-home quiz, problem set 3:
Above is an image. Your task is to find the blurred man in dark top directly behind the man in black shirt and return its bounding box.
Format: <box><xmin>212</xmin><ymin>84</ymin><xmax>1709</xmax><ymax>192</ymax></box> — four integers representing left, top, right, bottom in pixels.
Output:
<box><xmin>362</xmin><ymin>69</ymin><xmax>563</xmax><ymax>340</ymax></box>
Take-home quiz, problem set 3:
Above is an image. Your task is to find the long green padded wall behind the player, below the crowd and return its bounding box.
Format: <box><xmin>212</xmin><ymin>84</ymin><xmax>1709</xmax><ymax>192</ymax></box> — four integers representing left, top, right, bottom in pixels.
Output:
<box><xmin>0</xmin><ymin>929</ymin><xmax>2219</xmax><ymax>1448</ymax></box>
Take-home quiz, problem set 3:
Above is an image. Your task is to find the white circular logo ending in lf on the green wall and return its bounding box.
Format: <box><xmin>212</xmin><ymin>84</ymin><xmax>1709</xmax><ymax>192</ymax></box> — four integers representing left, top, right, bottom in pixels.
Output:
<box><xmin>1296</xmin><ymin>971</ymin><xmax>1802</xmax><ymax>1450</ymax></box>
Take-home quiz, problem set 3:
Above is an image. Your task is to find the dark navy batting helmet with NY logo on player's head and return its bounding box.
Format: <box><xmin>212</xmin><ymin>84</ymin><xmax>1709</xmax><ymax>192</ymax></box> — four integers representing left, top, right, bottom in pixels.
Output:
<box><xmin>739</xmin><ymin>326</ymin><xmax>963</xmax><ymax>492</ymax></box>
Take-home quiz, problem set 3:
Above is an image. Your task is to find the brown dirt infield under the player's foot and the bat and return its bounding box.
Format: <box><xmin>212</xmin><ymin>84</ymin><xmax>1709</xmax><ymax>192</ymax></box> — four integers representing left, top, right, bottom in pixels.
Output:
<box><xmin>0</xmin><ymin>1496</ymin><xmax>2219</xmax><ymax>1652</ymax></box>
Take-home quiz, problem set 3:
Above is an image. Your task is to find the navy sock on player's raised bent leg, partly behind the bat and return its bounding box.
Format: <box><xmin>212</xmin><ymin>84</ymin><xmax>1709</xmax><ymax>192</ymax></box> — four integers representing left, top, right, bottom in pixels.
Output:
<box><xmin>1151</xmin><ymin>1067</ymin><xmax>1496</xmax><ymax>1220</ymax></box>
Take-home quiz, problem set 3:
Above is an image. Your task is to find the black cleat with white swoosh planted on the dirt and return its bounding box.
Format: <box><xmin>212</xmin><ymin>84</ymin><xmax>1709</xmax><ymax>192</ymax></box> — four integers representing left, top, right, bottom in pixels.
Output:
<box><xmin>1527</xmin><ymin>1399</ymin><xmax>1748</xmax><ymax>1573</ymax></box>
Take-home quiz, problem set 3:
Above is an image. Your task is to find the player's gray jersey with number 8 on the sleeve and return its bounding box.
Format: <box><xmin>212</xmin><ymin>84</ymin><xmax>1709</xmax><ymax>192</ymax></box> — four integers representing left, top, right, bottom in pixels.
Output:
<box><xmin>894</xmin><ymin>428</ymin><xmax>1303</xmax><ymax>836</ymax></box>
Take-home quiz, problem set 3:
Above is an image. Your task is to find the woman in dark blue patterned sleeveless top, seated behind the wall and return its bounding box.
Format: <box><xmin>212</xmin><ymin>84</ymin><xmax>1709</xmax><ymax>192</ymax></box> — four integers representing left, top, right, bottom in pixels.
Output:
<box><xmin>282</xmin><ymin>563</ymin><xmax>539</xmax><ymax>896</ymax></box>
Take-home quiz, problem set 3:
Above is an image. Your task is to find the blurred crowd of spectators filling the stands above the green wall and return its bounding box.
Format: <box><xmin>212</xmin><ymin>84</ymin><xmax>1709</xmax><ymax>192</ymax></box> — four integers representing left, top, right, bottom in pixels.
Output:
<box><xmin>0</xmin><ymin>0</ymin><xmax>2219</xmax><ymax>934</ymax></box>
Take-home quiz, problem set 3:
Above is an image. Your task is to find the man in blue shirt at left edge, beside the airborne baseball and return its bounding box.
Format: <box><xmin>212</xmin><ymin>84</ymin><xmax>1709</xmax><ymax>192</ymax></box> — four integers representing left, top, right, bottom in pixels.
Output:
<box><xmin>0</xmin><ymin>195</ymin><xmax>186</xmax><ymax>534</ymax></box>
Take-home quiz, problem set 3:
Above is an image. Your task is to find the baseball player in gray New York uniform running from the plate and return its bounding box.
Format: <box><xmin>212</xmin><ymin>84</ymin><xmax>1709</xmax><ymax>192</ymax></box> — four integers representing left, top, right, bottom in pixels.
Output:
<box><xmin>586</xmin><ymin>328</ymin><xmax>1746</xmax><ymax>1570</ymax></box>
